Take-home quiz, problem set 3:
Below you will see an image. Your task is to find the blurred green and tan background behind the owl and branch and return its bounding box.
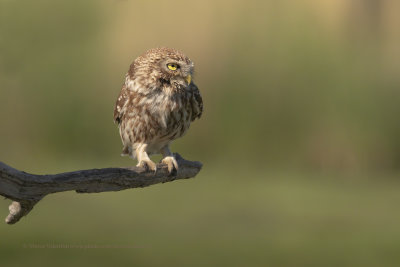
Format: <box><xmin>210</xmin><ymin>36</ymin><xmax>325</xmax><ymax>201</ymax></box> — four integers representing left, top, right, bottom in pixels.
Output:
<box><xmin>0</xmin><ymin>0</ymin><xmax>400</xmax><ymax>266</ymax></box>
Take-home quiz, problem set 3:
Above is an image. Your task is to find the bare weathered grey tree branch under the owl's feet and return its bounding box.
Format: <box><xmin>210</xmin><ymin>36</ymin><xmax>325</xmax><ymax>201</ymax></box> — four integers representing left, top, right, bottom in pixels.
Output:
<box><xmin>0</xmin><ymin>154</ymin><xmax>202</xmax><ymax>224</ymax></box>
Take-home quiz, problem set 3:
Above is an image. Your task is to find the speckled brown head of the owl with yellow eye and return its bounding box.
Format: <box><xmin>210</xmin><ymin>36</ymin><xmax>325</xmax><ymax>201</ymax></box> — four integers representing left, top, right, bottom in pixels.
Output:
<box><xmin>128</xmin><ymin>47</ymin><xmax>194</xmax><ymax>93</ymax></box>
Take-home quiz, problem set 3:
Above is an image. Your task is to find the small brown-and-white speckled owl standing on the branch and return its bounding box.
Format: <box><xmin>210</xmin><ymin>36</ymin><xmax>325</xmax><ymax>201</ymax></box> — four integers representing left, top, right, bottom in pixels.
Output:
<box><xmin>114</xmin><ymin>47</ymin><xmax>203</xmax><ymax>173</ymax></box>
